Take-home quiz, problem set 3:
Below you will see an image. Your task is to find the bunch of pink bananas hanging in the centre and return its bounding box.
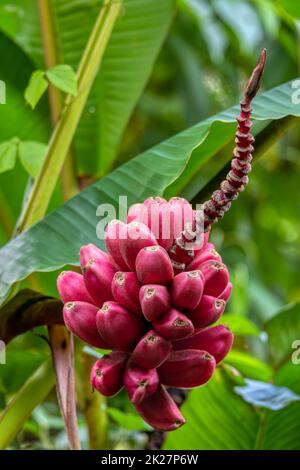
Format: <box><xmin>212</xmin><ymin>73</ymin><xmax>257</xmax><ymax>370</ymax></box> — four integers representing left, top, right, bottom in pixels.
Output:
<box><xmin>57</xmin><ymin>198</ymin><xmax>233</xmax><ymax>431</ymax></box>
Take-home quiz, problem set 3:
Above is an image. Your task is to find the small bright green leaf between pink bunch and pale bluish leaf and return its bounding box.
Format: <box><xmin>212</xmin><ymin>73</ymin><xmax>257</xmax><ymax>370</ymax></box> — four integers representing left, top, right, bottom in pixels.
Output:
<box><xmin>225</xmin><ymin>349</ymin><xmax>273</xmax><ymax>382</ymax></box>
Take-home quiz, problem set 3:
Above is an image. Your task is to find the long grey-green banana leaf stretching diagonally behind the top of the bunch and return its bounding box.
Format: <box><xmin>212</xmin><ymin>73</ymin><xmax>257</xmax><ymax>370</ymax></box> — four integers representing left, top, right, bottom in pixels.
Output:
<box><xmin>0</xmin><ymin>83</ymin><xmax>300</xmax><ymax>300</ymax></box>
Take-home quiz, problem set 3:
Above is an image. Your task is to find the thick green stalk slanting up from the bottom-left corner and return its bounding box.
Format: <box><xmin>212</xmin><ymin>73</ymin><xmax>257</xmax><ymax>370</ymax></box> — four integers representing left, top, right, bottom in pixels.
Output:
<box><xmin>0</xmin><ymin>359</ymin><xmax>55</xmax><ymax>449</ymax></box>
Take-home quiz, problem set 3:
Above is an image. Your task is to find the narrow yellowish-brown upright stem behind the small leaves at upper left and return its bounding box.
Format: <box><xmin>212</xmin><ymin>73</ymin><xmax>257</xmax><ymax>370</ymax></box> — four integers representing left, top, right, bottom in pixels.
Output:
<box><xmin>38</xmin><ymin>0</ymin><xmax>78</xmax><ymax>201</ymax></box>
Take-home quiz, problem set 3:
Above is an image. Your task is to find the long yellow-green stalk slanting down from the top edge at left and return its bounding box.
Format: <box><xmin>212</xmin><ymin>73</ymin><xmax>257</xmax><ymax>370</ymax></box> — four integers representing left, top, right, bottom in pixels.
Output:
<box><xmin>18</xmin><ymin>0</ymin><xmax>122</xmax><ymax>232</ymax></box>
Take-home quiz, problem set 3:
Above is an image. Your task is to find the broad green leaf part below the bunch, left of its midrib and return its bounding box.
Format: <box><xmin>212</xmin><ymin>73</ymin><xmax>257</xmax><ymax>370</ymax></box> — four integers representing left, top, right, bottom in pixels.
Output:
<box><xmin>163</xmin><ymin>370</ymin><xmax>259</xmax><ymax>450</ymax></box>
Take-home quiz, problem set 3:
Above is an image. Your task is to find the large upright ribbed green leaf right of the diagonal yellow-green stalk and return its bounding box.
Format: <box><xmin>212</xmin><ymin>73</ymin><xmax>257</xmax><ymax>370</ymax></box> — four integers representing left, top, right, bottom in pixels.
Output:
<box><xmin>75</xmin><ymin>0</ymin><xmax>176</xmax><ymax>176</ymax></box>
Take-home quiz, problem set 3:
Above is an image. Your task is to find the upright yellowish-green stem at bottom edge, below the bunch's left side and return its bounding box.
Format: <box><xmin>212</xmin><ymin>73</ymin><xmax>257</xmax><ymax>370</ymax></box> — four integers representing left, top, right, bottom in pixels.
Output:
<box><xmin>80</xmin><ymin>351</ymin><xmax>108</xmax><ymax>450</ymax></box>
